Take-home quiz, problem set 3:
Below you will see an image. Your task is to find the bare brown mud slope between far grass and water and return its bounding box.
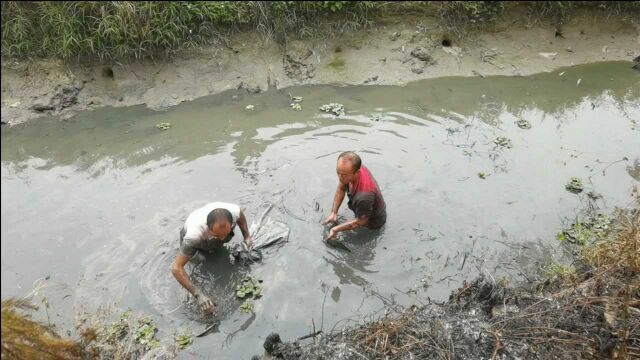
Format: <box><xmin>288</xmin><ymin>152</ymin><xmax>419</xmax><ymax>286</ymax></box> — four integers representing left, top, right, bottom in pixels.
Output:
<box><xmin>1</xmin><ymin>11</ymin><xmax>640</xmax><ymax>125</ymax></box>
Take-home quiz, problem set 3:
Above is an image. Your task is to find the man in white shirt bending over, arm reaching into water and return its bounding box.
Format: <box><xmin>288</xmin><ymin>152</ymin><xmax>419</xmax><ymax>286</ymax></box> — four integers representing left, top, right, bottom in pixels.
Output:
<box><xmin>171</xmin><ymin>202</ymin><xmax>253</xmax><ymax>312</ymax></box>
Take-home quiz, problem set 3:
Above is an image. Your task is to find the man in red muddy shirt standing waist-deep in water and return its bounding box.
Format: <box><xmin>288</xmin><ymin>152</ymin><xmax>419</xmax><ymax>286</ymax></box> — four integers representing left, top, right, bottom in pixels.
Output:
<box><xmin>324</xmin><ymin>151</ymin><xmax>387</xmax><ymax>240</ymax></box>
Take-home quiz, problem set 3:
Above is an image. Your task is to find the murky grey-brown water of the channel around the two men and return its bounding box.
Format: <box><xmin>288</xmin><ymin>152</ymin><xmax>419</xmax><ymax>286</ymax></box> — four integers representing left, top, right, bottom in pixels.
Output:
<box><xmin>2</xmin><ymin>63</ymin><xmax>640</xmax><ymax>359</ymax></box>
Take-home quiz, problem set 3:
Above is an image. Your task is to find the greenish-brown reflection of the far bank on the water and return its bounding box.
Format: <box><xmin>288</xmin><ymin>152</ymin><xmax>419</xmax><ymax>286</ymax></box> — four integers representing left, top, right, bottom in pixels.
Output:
<box><xmin>2</xmin><ymin>62</ymin><xmax>640</xmax><ymax>175</ymax></box>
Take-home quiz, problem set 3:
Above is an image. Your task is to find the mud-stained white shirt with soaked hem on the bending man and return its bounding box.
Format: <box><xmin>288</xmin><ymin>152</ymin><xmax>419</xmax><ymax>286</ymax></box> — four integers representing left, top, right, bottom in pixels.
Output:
<box><xmin>180</xmin><ymin>202</ymin><xmax>240</xmax><ymax>257</ymax></box>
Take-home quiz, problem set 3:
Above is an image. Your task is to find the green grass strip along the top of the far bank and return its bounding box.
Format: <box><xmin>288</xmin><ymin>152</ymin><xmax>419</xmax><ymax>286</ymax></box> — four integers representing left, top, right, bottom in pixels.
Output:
<box><xmin>2</xmin><ymin>1</ymin><xmax>640</xmax><ymax>59</ymax></box>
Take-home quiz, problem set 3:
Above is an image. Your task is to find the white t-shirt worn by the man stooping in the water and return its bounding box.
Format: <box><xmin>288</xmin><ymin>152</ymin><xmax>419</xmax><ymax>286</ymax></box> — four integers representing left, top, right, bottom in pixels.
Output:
<box><xmin>181</xmin><ymin>202</ymin><xmax>240</xmax><ymax>256</ymax></box>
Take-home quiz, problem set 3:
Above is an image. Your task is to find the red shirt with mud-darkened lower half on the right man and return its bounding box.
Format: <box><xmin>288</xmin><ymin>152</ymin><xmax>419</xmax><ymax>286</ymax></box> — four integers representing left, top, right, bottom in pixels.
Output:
<box><xmin>347</xmin><ymin>166</ymin><xmax>387</xmax><ymax>229</ymax></box>
